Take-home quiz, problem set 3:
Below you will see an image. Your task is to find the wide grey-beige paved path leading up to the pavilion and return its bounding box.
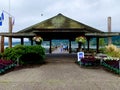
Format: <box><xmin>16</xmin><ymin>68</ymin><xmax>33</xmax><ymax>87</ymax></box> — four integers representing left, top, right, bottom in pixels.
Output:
<box><xmin>0</xmin><ymin>55</ymin><xmax>120</xmax><ymax>90</ymax></box>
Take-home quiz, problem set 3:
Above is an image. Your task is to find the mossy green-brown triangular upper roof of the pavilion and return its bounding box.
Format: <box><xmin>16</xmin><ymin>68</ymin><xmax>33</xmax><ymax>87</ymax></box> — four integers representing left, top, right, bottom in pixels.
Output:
<box><xmin>17</xmin><ymin>14</ymin><xmax>102</xmax><ymax>33</ymax></box>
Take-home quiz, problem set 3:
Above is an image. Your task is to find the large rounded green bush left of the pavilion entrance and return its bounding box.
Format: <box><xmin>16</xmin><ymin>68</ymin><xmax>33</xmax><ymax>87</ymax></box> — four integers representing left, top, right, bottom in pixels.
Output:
<box><xmin>3</xmin><ymin>45</ymin><xmax>45</xmax><ymax>64</ymax></box>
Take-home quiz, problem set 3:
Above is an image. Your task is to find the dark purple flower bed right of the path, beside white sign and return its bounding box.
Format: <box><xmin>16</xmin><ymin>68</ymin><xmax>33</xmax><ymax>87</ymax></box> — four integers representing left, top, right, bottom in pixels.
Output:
<box><xmin>76</xmin><ymin>55</ymin><xmax>120</xmax><ymax>75</ymax></box>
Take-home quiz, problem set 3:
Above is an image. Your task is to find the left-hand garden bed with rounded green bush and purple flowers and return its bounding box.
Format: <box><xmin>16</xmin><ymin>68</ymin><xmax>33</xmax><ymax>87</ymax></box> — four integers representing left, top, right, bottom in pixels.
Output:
<box><xmin>0</xmin><ymin>45</ymin><xmax>45</xmax><ymax>74</ymax></box>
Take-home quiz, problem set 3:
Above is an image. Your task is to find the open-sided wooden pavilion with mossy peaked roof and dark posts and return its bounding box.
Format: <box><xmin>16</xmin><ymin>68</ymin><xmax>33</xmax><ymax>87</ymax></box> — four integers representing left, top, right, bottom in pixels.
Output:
<box><xmin>0</xmin><ymin>14</ymin><xmax>120</xmax><ymax>53</ymax></box>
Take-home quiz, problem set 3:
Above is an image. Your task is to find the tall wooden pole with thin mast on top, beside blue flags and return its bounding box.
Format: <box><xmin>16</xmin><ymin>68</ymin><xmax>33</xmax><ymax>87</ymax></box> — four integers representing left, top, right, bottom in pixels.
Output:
<box><xmin>8</xmin><ymin>0</ymin><xmax>12</xmax><ymax>48</ymax></box>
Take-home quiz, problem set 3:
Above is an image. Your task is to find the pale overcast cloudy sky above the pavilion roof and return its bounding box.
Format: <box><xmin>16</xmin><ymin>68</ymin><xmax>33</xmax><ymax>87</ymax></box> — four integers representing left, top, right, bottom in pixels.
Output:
<box><xmin>0</xmin><ymin>0</ymin><xmax>120</xmax><ymax>32</ymax></box>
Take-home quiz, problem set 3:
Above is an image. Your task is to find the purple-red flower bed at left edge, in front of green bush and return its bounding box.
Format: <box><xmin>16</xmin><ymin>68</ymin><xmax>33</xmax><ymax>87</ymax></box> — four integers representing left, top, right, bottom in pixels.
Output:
<box><xmin>0</xmin><ymin>60</ymin><xmax>16</xmax><ymax>74</ymax></box>
